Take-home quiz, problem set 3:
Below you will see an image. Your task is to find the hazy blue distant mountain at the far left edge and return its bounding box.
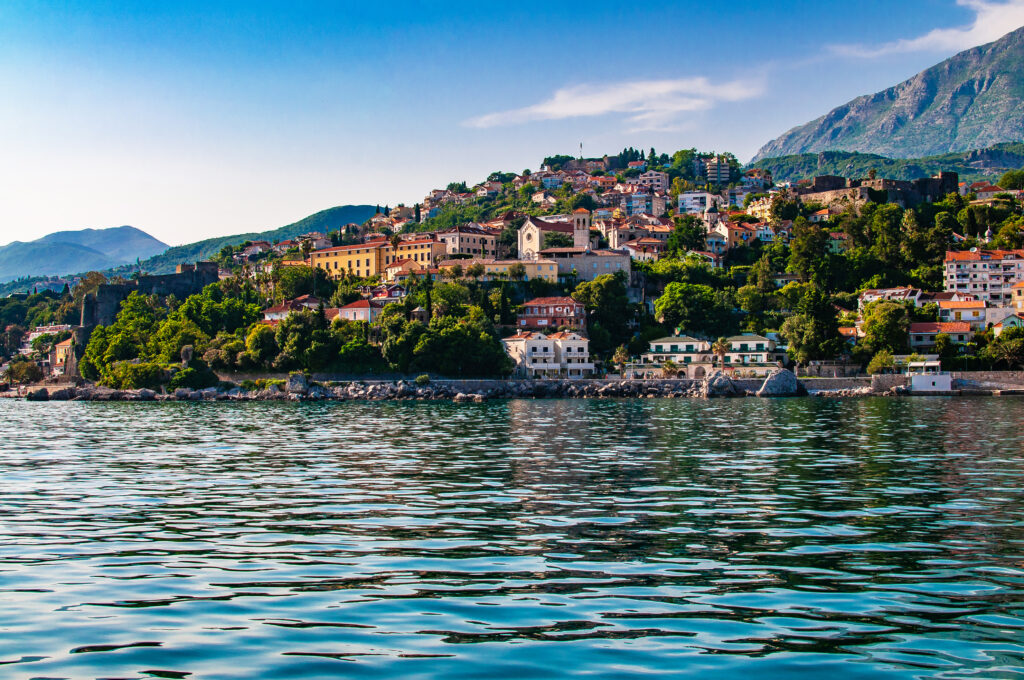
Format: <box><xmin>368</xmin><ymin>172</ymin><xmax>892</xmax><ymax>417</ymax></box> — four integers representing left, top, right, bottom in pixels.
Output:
<box><xmin>0</xmin><ymin>226</ymin><xmax>167</xmax><ymax>282</ymax></box>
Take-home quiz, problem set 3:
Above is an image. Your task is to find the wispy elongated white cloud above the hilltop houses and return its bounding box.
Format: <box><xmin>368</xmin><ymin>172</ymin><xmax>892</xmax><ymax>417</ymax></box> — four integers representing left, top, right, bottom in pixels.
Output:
<box><xmin>464</xmin><ymin>77</ymin><xmax>763</xmax><ymax>131</ymax></box>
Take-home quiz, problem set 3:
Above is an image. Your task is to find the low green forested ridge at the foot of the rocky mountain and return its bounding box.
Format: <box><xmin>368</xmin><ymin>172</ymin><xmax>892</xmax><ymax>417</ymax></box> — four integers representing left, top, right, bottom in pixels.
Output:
<box><xmin>750</xmin><ymin>142</ymin><xmax>1024</xmax><ymax>182</ymax></box>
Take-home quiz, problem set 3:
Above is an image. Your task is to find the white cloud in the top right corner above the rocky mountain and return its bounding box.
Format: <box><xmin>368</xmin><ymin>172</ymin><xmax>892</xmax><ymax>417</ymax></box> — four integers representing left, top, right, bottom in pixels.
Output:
<box><xmin>830</xmin><ymin>0</ymin><xmax>1024</xmax><ymax>57</ymax></box>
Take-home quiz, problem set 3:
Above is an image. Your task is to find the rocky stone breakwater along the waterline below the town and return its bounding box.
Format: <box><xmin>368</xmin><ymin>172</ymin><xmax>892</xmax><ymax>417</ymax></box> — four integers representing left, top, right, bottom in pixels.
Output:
<box><xmin>0</xmin><ymin>370</ymin><xmax>877</xmax><ymax>402</ymax></box>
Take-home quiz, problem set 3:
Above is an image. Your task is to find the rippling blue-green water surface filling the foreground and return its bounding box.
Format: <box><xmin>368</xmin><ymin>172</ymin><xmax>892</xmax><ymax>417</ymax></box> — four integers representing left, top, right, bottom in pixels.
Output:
<box><xmin>0</xmin><ymin>398</ymin><xmax>1024</xmax><ymax>679</ymax></box>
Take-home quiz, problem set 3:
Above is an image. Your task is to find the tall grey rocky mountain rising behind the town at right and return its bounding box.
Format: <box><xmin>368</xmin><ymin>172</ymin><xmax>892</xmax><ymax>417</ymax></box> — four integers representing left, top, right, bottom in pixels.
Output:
<box><xmin>754</xmin><ymin>27</ymin><xmax>1024</xmax><ymax>162</ymax></box>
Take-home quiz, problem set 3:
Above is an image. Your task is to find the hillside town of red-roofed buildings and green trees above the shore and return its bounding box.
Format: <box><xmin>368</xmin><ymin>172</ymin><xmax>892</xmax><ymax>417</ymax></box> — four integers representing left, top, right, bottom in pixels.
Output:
<box><xmin>0</xmin><ymin>148</ymin><xmax>1024</xmax><ymax>395</ymax></box>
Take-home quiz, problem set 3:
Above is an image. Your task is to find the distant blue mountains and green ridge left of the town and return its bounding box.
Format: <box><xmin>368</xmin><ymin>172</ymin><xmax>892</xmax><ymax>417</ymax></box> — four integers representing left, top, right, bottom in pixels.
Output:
<box><xmin>0</xmin><ymin>205</ymin><xmax>377</xmax><ymax>295</ymax></box>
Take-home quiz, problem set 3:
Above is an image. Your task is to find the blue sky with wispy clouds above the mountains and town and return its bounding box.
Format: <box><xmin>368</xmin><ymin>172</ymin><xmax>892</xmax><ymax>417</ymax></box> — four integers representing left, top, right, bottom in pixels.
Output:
<box><xmin>0</xmin><ymin>0</ymin><xmax>1024</xmax><ymax>244</ymax></box>
